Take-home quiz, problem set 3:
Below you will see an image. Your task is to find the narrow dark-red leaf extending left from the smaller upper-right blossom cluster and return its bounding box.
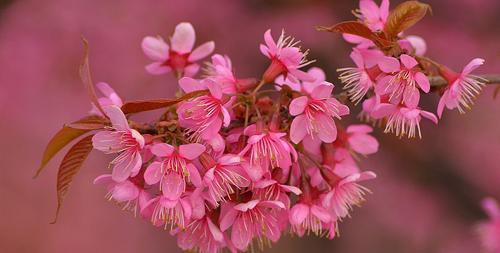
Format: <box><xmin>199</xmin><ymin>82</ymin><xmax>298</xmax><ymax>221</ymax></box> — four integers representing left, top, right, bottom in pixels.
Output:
<box><xmin>317</xmin><ymin>21</ymin><xmax>390</xmax><ymax>48</ymax></box>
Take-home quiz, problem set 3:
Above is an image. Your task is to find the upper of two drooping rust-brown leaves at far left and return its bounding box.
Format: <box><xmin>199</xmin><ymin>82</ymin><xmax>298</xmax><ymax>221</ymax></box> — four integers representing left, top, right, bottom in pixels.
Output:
<box><xmin>34</xmin><ymin>116</ymin><xmax>105</xmax><ymax>177</ymax></box>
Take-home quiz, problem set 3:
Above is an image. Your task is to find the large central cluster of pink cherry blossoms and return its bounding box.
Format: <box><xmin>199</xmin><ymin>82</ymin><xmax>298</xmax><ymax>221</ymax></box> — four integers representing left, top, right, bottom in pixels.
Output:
<box><xmin>91</xmin><ymin>23</ymin><xmax>378</xmax><ymax>252</ymax></box>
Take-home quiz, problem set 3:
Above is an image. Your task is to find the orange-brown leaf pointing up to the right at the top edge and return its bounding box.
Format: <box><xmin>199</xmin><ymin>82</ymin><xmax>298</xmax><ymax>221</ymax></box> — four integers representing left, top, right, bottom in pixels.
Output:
<box><xmin>384</xmin><ymin>1</ymin><xmax>431</xmax><ymax>40</ymax></box>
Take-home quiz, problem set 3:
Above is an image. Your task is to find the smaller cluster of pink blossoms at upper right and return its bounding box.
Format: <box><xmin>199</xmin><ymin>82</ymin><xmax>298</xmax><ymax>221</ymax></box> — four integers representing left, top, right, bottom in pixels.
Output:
<box><xmin>338</xmin><ymin>0</ymin><xmax>486</xmax><ymax>138</ymax></box>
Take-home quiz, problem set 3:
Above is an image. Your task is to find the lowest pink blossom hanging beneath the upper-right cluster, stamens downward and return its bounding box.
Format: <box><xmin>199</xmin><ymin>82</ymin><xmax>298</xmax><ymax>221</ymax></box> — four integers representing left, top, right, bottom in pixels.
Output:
<box><xmin>372</xmin><ymin>103</ymin><xmax>438</xmax><ymax>138</ymax></box>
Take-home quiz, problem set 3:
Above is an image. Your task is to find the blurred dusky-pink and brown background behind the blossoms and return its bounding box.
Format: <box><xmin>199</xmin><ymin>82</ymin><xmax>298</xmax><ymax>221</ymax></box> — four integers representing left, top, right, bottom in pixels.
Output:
<box><xmin>0</xmin><ymin>0</ymin><xmax>500</xmax><ymax>253</ymax></box>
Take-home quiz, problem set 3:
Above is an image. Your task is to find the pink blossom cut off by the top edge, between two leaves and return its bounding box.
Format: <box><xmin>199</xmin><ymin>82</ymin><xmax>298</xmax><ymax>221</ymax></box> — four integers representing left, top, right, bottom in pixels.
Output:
<box><xmin>357</xmin><ymin>0</ymin><xmax>389</xmax><ymax>31</ymax></box>
